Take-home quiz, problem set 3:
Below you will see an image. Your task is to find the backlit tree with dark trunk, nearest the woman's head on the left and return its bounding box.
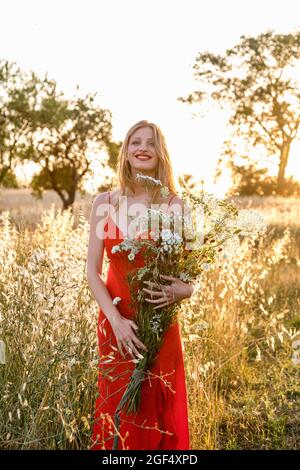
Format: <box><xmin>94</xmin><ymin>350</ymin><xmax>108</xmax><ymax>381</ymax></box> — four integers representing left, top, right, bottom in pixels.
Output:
<box><xmin>27</xmin><ymin>81</ymin><xmax>115</xmax><ymax>209</ymax></box>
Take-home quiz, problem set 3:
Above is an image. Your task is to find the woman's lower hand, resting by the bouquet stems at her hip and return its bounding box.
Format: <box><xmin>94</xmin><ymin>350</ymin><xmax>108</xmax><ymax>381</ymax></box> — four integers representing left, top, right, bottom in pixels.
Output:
<box><xmin>111</xmin><ymin>316</ymin><xmax>147</xmax><ymax>358</ymax></box>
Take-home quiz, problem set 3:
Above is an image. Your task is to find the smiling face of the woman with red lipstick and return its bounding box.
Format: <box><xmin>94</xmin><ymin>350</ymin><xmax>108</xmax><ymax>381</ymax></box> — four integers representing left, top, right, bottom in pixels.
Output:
<box><xmin>127</xmin><ymin>127</ymin><xmax>158</xmax><ymax>176</ymax></box>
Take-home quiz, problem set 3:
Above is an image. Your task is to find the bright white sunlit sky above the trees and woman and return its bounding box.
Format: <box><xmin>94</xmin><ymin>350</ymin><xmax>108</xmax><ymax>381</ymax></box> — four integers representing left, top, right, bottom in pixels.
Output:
<box><xmin>0</xmin><ymin>0</ymin><xmax>300</xmax><ymax>195</ymax></box>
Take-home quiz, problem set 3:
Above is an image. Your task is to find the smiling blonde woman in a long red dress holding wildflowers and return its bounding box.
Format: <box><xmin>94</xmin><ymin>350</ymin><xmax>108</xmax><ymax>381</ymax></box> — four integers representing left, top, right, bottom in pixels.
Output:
<box><xmin>87</xmin><ymin>121</ymin><xmax>193</xmax><ymax>450</ymax></box>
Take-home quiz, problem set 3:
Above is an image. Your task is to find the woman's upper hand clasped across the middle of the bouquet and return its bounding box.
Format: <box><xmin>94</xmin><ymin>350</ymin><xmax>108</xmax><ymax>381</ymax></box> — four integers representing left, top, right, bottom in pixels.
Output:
<box><xmin>143</xmin><ymin>274</ymin><xmax>193</xmax><ymax>310</ymax></box>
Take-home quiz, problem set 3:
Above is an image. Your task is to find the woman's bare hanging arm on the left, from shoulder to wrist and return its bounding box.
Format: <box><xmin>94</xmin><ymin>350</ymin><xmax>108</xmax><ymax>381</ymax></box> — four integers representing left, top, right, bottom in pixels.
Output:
<box><xmin>87</xmin><ymin>192</ymin><xmax>121</xmax><ymax>324</ymax></box>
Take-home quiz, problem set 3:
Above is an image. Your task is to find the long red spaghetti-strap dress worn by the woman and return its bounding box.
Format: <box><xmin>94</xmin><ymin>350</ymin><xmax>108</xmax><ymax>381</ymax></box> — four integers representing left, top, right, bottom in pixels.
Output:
<box><xmin>90</xmin><ymin>192</ymin><xmax>190</xmax><ymax>450</ymax></box>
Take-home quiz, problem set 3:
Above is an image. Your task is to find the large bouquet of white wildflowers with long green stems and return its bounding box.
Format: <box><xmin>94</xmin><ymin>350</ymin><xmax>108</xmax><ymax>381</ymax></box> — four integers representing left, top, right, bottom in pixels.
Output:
<box><xmin>114</xmin><ymin>175</ymin><xmax>266</xmax><ymax>448</ymax></box>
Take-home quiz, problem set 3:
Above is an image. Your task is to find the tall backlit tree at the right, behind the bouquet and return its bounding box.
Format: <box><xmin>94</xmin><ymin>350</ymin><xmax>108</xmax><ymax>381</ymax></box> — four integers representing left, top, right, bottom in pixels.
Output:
<box><xmin>178</xmin><ymin>30</ymin><xmax>300</xmax><ymax>193</ymax></box>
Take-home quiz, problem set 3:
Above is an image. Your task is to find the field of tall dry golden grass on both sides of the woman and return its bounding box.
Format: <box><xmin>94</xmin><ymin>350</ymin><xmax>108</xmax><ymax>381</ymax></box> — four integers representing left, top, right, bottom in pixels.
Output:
<box><xmin>0</xmin><ymin>190</ymin><xmax>300</xmax><ymax>450</ymax></box>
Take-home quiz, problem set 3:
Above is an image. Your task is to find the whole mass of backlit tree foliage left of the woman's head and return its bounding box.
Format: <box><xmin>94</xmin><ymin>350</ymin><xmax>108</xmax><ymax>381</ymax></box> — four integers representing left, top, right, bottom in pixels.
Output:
<box><xmin>0</xmin><ymin>61</ymin><xmax>121</xmax><ymax>209</ymax></box>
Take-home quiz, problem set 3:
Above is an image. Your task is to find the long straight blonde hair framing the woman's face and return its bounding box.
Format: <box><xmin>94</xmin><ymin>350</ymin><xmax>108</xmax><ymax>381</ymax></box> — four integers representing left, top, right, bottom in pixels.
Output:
<box><xmin>112</xmin><ymin>120</ymin><xmax>178</xmax><ymax>210</ymax></box>
